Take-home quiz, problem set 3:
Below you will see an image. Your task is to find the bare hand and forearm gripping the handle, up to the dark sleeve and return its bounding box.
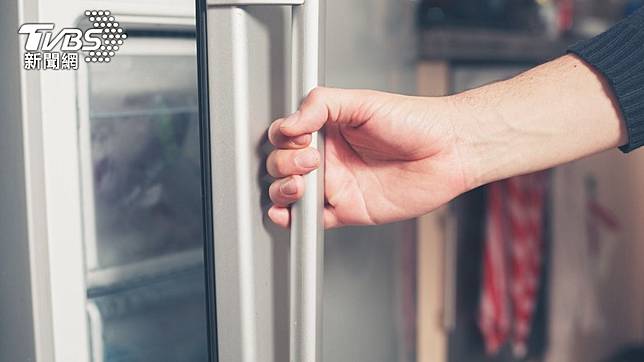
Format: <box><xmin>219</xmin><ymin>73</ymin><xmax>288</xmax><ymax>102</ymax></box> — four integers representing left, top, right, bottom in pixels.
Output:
<box><xmin>267</xmin><ymin>55</ymin><xmax>627</xmax><ymax>227</ymax></box>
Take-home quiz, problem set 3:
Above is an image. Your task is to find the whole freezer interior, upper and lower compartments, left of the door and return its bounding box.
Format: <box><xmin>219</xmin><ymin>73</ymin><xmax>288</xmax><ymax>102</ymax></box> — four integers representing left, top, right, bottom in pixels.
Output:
<box><xmin>81</xmin><ymin>32</ymin><xmax>208</xmax><ymax>362</ymax></box>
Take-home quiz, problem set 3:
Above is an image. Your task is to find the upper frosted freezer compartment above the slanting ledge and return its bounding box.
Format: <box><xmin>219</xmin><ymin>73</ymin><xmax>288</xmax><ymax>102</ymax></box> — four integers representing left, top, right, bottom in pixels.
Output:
<box><xmin>83</xmin><ymin>37</ymin><xmax>203</xmax><ymax>270</ymax></box>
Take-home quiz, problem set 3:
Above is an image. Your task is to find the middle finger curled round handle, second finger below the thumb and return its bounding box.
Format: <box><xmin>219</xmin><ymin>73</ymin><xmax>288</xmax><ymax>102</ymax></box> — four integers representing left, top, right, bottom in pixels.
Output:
<box><xmin>266</xmin><ymin>148</ymin><xmax>320</xmax><ymax>178</ymax></box>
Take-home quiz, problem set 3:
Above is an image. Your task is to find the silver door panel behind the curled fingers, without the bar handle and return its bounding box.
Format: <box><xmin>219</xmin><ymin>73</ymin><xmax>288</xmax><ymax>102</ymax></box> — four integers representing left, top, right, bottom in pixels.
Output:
<box><xmin>207</xmin><ymin>6</ymin><xmax>291</xmax><ymax>362</ymax></box>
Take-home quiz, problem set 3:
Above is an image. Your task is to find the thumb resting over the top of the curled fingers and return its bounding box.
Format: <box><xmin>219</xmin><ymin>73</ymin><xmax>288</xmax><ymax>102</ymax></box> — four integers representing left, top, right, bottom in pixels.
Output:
<box><xmin>280</xmin><ymin>87</ymin><xmax>377</xmax><ymax>137</ymax></box>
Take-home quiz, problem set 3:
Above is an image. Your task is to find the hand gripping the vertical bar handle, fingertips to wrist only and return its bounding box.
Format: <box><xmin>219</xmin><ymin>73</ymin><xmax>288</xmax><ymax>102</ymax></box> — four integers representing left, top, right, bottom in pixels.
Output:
<box><xmin>267</xmin><ymin>88</ymin><xmax>470</xmax><ymax>227</ymax></box>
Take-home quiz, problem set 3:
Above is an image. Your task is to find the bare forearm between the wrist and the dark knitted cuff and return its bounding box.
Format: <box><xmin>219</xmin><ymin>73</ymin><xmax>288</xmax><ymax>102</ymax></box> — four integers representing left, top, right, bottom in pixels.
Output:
<box><xmin>448</xmin><ymin>55</ymin><xmax>627</xmax><ymax>188</ymax></box>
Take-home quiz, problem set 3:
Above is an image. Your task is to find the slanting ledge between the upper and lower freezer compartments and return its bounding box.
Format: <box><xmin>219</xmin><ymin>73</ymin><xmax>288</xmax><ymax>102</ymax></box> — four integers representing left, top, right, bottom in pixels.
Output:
<box><xmin>87</xmin><ymin>248</ymin><xmax>203</xmax><ymax>299</ymax></box>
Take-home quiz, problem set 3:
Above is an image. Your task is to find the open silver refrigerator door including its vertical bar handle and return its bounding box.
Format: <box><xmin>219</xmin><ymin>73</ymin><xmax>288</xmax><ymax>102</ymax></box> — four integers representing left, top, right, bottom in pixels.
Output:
<box><xmin>198</xmin><ymin>0</ymin><xmax>324</xmax><ymax>362</ymax></box>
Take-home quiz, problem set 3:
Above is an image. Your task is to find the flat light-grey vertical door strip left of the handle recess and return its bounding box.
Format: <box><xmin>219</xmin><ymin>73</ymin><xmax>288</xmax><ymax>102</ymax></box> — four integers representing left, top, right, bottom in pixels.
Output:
<box><xmin>208</xmin><ymin>7</ymin><xmax>257</xmax><ymax>362</ymax></box>
